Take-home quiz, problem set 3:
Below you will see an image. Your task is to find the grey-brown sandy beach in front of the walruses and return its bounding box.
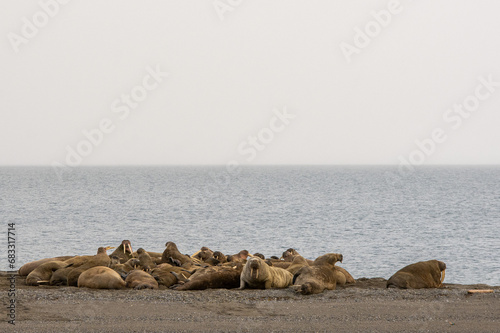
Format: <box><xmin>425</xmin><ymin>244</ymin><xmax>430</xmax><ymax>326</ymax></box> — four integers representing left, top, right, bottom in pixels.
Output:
<box><xmin>0</xmin><ymin>272</ymin><xmax>500</xmax><ymax>332</ymax></box>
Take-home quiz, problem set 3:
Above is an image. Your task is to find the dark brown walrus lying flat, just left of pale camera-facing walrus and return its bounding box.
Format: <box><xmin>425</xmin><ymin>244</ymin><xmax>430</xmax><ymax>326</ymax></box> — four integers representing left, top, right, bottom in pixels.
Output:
<box><xmin>172</xmin><ymin>262</ymin><xmax>243</xmax><ymax>290</ymax></box>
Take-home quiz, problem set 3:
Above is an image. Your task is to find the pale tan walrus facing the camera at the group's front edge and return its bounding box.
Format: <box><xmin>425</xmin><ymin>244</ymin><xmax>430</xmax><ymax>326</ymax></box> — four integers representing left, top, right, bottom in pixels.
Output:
<box><xmin>240</xmin><ymin>257</ymin><xmax>293</xmax><ymax>289</ymax></box>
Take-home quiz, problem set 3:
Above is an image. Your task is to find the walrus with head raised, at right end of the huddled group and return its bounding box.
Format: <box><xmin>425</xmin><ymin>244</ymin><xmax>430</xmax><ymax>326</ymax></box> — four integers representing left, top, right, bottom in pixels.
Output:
<box><xmin>292</xmin><ymin>253</ymin><xmax>343</xmax><ymax>295</ymax></box>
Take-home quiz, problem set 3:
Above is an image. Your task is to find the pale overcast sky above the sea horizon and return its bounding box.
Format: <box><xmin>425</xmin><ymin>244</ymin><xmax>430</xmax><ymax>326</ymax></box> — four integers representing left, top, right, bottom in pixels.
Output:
<box><xmin>0</xmin><ymin>0</ymin><xmax>500</xmax><ymax>166</ymax></box>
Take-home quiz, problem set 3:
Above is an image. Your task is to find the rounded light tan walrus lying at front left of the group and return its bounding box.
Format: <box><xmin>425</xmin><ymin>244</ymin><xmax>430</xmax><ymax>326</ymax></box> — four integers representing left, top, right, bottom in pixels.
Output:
<box><xmin>78</xmin><ymin>266</ymin><xmax>125</xmax><ymax>289</ymax></box>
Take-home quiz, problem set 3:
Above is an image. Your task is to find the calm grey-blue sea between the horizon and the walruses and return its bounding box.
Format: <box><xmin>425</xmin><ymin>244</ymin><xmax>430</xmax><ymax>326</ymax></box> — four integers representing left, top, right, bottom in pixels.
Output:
<box><xmin>0</xmin><ymin>166</ymin><xmax>500</xmax><ymax>285</ymax></box>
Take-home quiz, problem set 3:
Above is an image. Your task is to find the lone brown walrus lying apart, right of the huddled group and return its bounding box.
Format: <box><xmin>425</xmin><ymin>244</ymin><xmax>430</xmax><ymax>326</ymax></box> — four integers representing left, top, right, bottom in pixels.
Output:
<box><xmin>387</xmin><ymin>260</ymin><xmax>446</xmax><ymax>289</ymax></box>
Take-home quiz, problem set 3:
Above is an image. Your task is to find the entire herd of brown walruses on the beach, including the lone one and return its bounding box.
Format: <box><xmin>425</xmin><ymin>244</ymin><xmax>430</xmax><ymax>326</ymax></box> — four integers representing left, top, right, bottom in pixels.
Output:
<box><xmin>19</xmin><ymin>240</ymin><xmax>446</xmax><ymax>295</ymax></box>
